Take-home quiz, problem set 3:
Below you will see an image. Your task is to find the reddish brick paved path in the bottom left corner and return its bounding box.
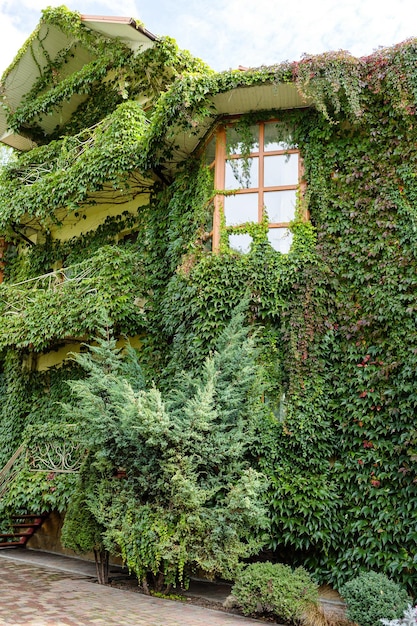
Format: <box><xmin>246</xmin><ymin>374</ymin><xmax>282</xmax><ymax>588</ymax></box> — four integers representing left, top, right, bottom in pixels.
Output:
<box><xmin>0</xmin><ymin>558</ymin><xmax>260</xmax><ymax>626</ymax></box>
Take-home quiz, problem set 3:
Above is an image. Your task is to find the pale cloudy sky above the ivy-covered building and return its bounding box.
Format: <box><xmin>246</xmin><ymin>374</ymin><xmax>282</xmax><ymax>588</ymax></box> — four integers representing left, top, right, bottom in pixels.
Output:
<box><xmin>0</xmin><ymin>0</ymin><xmax>417</xmax><ymax>75</ymax></box>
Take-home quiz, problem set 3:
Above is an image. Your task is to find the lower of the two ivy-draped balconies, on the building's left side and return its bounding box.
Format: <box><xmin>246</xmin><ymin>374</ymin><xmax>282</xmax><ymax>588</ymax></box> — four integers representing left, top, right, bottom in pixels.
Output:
<box><xmin>0</xmin><ymin>245</ymin><xmax>144</xmax><ymax>352</ymax></box>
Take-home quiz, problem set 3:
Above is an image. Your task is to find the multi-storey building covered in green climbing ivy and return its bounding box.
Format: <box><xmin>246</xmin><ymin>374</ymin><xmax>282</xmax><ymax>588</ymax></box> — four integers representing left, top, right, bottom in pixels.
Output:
<box><xmin>0</xmin><ymin>7</ymin><xmax>417</xmax><ymax>586</ymax></box>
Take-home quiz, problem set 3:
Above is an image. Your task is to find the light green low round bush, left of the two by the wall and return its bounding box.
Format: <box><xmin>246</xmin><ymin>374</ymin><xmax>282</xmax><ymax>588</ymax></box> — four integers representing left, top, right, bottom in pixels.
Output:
<box><xmin>232</xmin><ymin>562</ymin><xmax>318</xmax><ymax>623</ymax></box>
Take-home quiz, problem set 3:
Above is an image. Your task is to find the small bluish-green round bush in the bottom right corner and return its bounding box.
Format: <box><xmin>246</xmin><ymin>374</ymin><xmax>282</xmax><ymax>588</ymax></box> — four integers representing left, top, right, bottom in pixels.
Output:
<box><xmin>339</xmin><ymin>572</ymin><xmax>411</xmax><ymax>626</ymax></box>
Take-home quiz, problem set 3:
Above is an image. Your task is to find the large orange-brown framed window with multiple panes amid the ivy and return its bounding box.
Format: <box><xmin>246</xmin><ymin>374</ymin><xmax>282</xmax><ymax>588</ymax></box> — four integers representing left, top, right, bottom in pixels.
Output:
<box><xmin>209</xmin><ymin>122</ymin><xmax>301</xmax><ymax>252</ymax></box>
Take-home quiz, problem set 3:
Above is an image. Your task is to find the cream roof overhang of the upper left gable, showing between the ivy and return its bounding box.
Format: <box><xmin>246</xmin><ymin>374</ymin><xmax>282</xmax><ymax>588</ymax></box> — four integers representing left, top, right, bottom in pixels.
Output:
<box><xmin>0</xmin><ymin>15</ymin><xmax>156</xmax><ymax>150</ymax></box>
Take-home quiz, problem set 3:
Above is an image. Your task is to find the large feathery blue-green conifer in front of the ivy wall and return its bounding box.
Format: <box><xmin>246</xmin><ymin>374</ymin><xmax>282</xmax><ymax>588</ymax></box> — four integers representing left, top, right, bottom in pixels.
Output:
<box><xmin>64</xmin><ymin>311</ymin><xmax>268</xmax><ymax>592</ymax></box>
